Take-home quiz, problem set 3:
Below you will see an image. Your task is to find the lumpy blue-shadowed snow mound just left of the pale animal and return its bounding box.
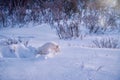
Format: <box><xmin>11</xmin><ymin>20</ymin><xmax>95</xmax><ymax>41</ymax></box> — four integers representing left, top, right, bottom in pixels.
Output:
<box><xmin>0</xmin><ymin>43</ymin><xmax>35</xmax><ymax>58</ymax></box>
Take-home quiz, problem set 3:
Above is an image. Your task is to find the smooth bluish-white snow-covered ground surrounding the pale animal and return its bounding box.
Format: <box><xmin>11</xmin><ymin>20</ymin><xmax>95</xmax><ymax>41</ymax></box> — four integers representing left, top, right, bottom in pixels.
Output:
<box><xmin>0</xmin><ymin>24</ymin><xmax>120</xmax><ymax>80</ymax></box>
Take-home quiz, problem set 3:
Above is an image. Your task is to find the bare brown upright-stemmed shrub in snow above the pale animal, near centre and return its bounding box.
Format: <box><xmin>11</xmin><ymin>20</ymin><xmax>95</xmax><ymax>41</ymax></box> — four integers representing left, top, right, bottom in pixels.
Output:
<box><xmin>56</xmin><ymin>20</ymin><xmax>79</xmax><ymax>39</ymax></box>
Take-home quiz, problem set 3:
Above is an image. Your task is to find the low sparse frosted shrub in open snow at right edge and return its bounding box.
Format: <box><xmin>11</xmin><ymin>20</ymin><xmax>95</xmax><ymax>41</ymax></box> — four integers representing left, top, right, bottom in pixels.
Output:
<box><xmin>93</xmin><ymin>37</ymin><xmax>120</xmax><ymax>48</ymax></box>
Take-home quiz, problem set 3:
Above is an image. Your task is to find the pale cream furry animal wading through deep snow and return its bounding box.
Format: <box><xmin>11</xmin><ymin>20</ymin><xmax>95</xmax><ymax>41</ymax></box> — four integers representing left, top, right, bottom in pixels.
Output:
<box><xmin>36</xmin><ymin>42</ymin><xmax>60</xmax><ymax>58</ymax></box>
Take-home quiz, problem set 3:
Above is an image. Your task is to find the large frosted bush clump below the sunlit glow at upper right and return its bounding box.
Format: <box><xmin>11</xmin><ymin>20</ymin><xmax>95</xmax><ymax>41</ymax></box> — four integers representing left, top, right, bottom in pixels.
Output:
<box><xmin>81</xmin><ymin>8</ymin><xmax>120</xmax><ymax>33</ymax></box>
